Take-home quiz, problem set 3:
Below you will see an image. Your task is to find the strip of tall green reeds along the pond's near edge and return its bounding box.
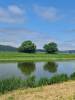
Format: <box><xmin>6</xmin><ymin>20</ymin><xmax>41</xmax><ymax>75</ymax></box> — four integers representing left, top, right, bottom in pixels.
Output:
<box><xmin>0</xmin><ymin>73</ymin><xmax>75</xmax><ymax>94</ymax></box>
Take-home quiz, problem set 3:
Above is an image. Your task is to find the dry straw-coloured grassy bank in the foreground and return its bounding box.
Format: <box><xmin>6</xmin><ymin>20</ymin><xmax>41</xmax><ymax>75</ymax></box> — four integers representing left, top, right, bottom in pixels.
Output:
<box><xmin>0</xmin><ymin>81</ymin><xmax>75</xmax><ymax>100</ymax></box>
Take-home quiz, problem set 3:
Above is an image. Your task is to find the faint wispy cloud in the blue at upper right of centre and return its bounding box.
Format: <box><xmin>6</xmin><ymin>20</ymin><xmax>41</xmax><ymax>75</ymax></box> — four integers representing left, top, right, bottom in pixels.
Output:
<box><xmin>33</xmin><ymin>5</ymin><xmax>63</xmax><ymax>21</ymax></box>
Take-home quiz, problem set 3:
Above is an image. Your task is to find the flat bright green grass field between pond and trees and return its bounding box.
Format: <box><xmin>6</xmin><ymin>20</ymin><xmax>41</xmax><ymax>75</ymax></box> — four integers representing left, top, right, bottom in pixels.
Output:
<box><xmin>0</xmin><ymin>52</ymin><xmax>75</xmax><ymax>61</ymax></box>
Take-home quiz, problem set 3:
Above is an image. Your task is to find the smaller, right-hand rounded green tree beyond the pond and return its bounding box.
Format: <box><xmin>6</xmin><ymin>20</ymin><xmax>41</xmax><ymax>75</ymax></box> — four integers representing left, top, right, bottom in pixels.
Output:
<box><xmin>43</xmin><ymin>42</ymin><xmax>58</xmax><ymax>54</ymax></box>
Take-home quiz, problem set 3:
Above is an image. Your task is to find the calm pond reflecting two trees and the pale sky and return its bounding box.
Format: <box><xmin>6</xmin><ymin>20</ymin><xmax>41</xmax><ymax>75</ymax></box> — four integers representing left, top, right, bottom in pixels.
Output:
<box><xmin>0</xmin><ymin>61</ymin><xmax>75</xmax><ymax>79</ymax></box>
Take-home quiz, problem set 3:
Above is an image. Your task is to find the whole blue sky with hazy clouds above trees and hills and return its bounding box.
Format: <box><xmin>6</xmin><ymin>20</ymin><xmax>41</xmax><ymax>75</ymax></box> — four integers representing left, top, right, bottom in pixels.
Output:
<box><xmin>0</xmin><ymin>0</ymin><xmax>75</xmax><ymax>50</ymax></box>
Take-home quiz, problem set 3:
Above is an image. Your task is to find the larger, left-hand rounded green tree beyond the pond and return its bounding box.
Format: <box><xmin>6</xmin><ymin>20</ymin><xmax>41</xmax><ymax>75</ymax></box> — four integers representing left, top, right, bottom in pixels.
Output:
<box><xmin>18</xmin><ymin>41</ymin><xmax>36</xmax><ymax>53</ymax></box>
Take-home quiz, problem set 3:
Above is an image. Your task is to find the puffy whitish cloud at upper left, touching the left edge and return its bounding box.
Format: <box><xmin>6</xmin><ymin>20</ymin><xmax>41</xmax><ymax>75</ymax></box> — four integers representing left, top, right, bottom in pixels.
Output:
<box><xmin>0</xmin><ymin>5</ymin><xmax>25</xmax><ymax>23</ymax></box>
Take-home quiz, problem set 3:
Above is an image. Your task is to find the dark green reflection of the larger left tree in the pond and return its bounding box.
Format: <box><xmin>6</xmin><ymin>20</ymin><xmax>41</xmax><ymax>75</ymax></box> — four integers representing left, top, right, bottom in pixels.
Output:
<box><xmin>18</xmin><ymin>62</ymin><xmax>35</xmax><ymax>75</ymax></box>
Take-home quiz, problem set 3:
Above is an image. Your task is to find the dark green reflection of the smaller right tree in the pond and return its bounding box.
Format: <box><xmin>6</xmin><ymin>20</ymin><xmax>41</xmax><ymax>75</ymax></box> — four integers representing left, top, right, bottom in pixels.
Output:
<box><xmin>44</xmin><ymin>62</ymin><xmax>58</xmax><ymax>73</ymax></box>
